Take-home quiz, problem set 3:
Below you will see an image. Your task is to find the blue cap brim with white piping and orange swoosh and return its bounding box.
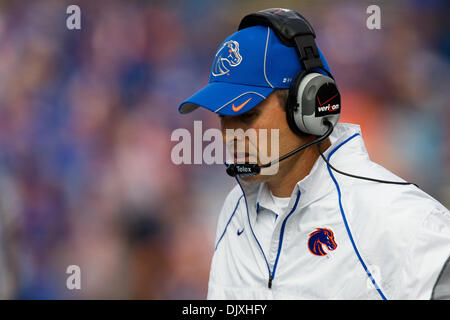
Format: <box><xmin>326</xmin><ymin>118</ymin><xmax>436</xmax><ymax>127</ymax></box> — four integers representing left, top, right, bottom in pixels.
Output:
<box><xmin>178</xmin><ymin>82</ymin><xmax>275</xmax><ymax>116</ymax></box>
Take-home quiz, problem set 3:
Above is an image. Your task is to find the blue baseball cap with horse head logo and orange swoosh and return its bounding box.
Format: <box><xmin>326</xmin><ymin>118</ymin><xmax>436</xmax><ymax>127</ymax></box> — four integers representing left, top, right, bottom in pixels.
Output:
<box><xmin>178</xmin><ymin>26</ymin><xmax>330</xmax><ymax>115</ymax></box>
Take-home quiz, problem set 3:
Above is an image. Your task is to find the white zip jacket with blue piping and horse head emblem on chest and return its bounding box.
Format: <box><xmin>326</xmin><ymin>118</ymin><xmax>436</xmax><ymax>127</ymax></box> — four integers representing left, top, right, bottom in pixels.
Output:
<box><xmin>208</xmin><ymin>124</ymin><xmax>450</xmax><ymax>299</ymax></box>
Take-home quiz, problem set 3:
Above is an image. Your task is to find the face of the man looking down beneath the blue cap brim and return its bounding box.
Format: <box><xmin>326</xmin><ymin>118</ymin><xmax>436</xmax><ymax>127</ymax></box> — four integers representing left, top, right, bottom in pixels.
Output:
<box><xmin>219</xmin><ymin>93</ymin><xmax>301</xmax><ymax>182</ymax></box>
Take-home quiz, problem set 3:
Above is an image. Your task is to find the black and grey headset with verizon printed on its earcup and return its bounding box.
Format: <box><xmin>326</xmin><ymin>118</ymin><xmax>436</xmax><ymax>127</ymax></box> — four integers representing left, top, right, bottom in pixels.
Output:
<box><xmin>238</xmin><ymin>8</ymin><xmax>341</xmax><ymax>136</ymax></box>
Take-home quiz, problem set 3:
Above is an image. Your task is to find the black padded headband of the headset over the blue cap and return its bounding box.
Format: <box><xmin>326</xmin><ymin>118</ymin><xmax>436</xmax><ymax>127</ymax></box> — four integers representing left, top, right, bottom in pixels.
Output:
<box><xmin>238</xmin><ymin>9</ymin><xmax>325</xmax><ymax>71</ymax></box>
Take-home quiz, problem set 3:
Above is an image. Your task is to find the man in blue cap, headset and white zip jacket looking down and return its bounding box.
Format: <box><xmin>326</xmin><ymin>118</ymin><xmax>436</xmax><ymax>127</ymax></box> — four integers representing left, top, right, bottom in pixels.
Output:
<box><xmin>179</xmin><ymin>9</ymin><xmax>450</xmax><ymax>299</ymax></box>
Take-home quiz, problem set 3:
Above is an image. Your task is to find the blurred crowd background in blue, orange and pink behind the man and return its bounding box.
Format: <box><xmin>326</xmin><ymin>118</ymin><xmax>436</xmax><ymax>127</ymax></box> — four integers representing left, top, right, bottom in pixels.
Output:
<box><xmin>0</xmin><ymin>0</ymin><xmax>450</xmax><ymax>299</ymax></box>
